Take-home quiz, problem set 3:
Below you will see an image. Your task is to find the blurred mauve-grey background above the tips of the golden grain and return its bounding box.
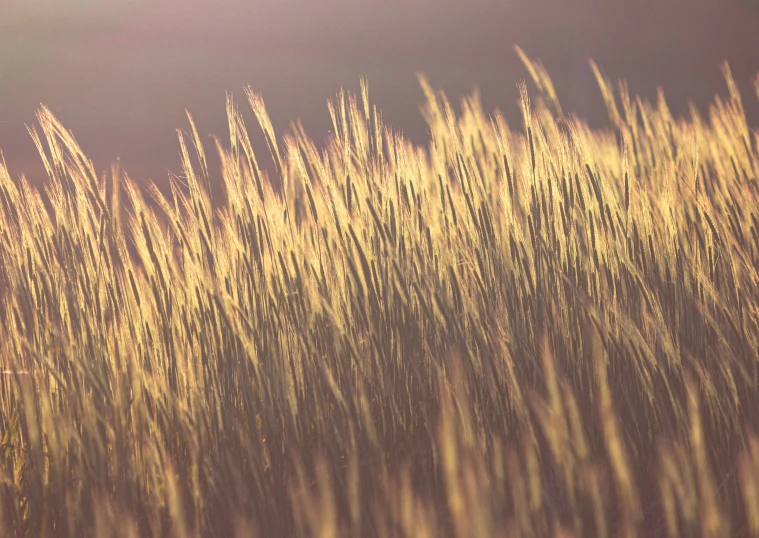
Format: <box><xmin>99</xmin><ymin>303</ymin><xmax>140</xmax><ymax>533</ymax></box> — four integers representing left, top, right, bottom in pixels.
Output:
<box><xmin>0</xmin><ymin>0</ymin><xmax>759</xmax><ymax>184</ymax></box>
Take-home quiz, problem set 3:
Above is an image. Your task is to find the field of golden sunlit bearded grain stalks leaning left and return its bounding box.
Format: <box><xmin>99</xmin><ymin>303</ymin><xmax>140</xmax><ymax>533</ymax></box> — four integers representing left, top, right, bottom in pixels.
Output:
<box><xmin>0</xmin><ymin>51</ymin><xmax>759</xmax><ymax>538</ymax></box>
